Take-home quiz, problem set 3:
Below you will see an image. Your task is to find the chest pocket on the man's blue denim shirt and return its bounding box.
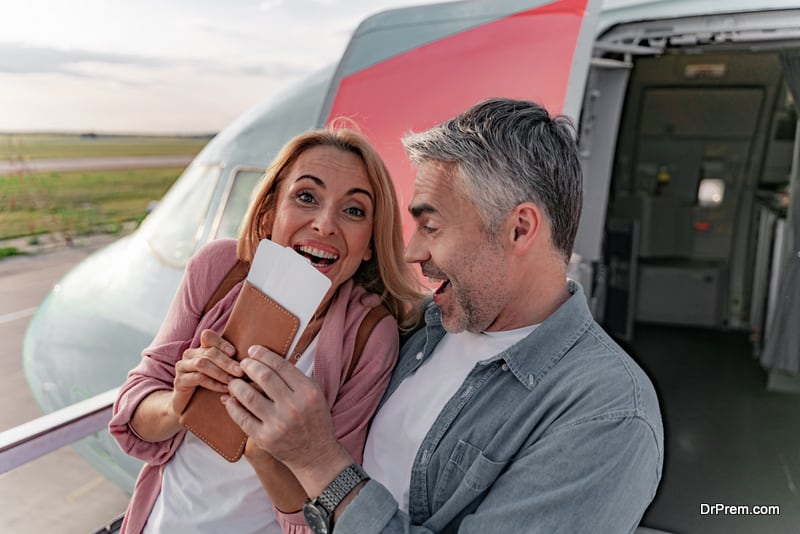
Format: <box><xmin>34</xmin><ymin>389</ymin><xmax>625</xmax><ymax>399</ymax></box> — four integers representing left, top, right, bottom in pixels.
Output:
<box><xmin>431</xmin><ymin>440</ymin><xmax>508</xmax><ymax>510</ymax></box>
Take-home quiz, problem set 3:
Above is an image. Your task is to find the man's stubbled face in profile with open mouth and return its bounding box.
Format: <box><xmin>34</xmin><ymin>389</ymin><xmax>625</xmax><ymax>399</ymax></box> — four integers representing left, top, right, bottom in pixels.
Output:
<box><xmin>406</xmin><ymin>162</ymin><xmax>508</xmax><ymax>333</ymax></box>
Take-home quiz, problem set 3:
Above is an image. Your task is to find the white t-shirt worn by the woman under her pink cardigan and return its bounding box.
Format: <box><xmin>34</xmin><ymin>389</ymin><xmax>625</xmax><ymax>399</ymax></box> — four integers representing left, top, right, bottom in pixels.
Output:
<box><xmin>143</xmin><ymin>338</ymin><xmax>317</xmax><ymax>534</ymax></box>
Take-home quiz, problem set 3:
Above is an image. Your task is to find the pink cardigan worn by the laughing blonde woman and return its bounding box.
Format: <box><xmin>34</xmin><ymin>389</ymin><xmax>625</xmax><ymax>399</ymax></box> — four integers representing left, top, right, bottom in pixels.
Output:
<box><xmin>109</xmin><ymin>239</ymin><xmax>399</xmax><ymax>534</ymax></box>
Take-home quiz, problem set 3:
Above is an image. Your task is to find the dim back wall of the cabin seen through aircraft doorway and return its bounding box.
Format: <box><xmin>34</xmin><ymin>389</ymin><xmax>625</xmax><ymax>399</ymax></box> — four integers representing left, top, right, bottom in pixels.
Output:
<box><xmin>606</xmin><ymin>46</ymin><xmax>794</xmax><ymax>340</ymax></box>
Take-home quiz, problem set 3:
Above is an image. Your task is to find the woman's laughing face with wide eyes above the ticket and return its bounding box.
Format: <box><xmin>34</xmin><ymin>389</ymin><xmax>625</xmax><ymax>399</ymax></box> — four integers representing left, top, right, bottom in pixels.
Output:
<box><xmin>271</xmin><ymin>146</ymin><xmax>375</xmax><ymax>294</ymax></box>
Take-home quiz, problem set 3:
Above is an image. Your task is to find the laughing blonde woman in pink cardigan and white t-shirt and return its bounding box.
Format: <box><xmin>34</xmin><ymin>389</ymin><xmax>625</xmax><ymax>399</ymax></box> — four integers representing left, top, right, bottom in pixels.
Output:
<box><xmin>109</xmin><ymin>129</ymin><xmax>420</xmax><ymax>533</ymax></box>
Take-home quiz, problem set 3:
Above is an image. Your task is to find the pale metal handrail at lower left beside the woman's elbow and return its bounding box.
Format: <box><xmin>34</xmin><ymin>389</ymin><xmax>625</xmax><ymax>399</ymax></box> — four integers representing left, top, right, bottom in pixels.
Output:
<box><xmin>0</xmin><ymin>387</ymin><xmax>119</xmax><ymax>474</ymax></box>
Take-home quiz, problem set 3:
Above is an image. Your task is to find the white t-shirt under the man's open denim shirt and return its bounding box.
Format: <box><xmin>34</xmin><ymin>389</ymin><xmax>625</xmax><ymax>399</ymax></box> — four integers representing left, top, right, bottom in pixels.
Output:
<box><xmin>364</xmin><ymin>325</ymin><xmax>537</xmax><ymax>512</ymax></box>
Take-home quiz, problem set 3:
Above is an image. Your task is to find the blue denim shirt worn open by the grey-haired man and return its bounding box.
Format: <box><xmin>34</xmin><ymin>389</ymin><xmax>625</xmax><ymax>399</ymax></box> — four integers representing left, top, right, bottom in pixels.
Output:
<box><xmin>335</xmin><ymin>281</ymin><xmax>664</xmax><ymax>534</ymax></box>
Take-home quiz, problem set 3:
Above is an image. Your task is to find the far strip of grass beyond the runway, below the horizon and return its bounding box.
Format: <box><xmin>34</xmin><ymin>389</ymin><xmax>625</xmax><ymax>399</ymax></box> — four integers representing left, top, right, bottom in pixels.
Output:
<box><xmin>0</xmin><ymin>133</ymin><xmax>211</xmax><ymax>160</ymax></box>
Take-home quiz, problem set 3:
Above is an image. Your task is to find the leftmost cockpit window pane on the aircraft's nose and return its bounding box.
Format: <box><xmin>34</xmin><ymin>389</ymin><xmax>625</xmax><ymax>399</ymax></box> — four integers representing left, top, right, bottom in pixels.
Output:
<box><xmin>142</xmin><ymin>165</ymin><xmax>222</xmax><ymax>267</ymax></box>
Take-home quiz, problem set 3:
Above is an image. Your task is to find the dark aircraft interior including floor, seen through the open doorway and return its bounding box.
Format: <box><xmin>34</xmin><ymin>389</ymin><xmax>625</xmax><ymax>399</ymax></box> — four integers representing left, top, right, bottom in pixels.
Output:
<box><xmin>582</xmin><ymin>12</ymin><xmax>800</xmax><ymax>533</ymax></box>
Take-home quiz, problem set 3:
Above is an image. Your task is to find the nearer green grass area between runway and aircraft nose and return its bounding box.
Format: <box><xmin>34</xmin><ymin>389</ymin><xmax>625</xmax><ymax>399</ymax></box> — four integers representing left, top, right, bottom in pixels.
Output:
<box><xmin>0</xmin><ymin>168</ymin><xmax>183</xmax><ymax>240</ymax></box>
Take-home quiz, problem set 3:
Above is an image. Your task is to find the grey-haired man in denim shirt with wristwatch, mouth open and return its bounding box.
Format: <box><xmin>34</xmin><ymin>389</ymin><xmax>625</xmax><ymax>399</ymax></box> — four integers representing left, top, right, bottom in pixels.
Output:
<box><xmin>227</xmin><ymin>99</ymin><xmax>663</xmax><ymax>534</ymax></box>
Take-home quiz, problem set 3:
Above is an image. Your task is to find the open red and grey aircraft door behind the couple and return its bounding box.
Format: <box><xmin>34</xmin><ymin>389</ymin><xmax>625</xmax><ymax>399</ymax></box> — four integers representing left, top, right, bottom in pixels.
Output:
<box><xmin>320</xmin><ymin>0</ymin><xmax>600</xmax><ymax>241</ymax></box>
